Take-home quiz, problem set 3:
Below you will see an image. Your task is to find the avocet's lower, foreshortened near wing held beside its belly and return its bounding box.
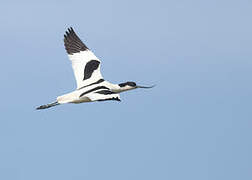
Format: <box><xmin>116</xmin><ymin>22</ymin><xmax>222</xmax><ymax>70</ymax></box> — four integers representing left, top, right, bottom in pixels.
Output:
<box><xmin>85</xmin><ymin>89</ymin><xmax>121</xmax><ymax>101</ymax></box>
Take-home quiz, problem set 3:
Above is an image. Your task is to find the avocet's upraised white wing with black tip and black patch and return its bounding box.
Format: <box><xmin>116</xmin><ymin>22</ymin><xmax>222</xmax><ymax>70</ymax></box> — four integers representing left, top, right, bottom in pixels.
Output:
<box><xmin>64</xmin><ymin>28</ymin><xmax>103</xmax><ymax>89</ymax></box>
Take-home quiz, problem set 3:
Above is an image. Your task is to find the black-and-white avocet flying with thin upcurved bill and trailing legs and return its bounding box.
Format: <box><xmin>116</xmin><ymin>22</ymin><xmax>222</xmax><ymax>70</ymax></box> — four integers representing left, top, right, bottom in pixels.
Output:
<box><xmin>36</xmin><ymin>27</ymin><xmax>154</xmax><ymax>109</ymax></box>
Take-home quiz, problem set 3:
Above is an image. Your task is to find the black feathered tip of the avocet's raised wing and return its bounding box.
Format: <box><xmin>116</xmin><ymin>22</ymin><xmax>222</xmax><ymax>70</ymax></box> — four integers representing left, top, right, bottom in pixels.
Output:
<box><xmin>64</xmin><ymin>27</ymin><xmax>88</xmax><ymax>55</ymax></box>
